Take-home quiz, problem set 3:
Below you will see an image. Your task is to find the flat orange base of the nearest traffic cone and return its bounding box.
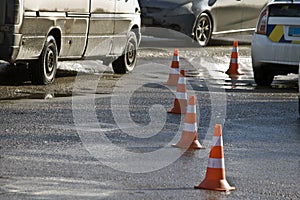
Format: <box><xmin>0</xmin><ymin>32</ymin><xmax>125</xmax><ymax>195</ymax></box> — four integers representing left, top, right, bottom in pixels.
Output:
<box><xmin>194</xmin><ymin>179</ymin><xmax>236</xmax><ymax>191</ymax></box>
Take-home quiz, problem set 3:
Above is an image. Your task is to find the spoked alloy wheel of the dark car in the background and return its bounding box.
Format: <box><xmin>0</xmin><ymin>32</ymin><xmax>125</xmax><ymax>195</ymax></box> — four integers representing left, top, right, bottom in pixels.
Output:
<box><xmin>194</xmin><ymin>13</ymin><xmax>212</xmax><ymax>46</ymax></box>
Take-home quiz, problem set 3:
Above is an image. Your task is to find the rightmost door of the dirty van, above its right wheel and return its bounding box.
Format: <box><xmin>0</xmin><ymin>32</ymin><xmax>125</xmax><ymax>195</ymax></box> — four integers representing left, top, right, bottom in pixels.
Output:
<box><xmin>113</xmin><ymin>0</ymin><xmax>138</xmax><ymax>55</ymax></box>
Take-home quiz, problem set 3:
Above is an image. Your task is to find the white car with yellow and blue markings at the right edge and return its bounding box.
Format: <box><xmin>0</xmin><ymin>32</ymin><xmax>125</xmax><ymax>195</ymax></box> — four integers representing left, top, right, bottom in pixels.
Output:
<box><xmin>251</xmin><ymin>0</ymin><xmax>300</xmax><ymax>86</ymax></box>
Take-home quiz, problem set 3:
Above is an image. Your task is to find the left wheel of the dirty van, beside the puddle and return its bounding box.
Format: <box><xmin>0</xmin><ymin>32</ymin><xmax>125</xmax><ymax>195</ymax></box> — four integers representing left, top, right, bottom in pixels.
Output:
<box><xmin>31</xmin><ymin>35</ymin><xmax>58</xmax><ymax>85</ymax></box>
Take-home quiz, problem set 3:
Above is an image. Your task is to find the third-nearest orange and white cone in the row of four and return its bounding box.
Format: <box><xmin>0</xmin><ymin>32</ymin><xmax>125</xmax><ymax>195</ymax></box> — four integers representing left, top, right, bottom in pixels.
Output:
<box><xmin>169</xmin><ymin>70</ymin><xmax>187</xmax><ymax>114</ymax></box>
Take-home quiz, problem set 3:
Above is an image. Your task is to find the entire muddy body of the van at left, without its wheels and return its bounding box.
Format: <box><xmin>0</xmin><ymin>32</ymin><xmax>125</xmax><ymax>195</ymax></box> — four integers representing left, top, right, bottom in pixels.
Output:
<box><xmin>0</xmin><ymin>0</ymin><xmax>140</xmax><ymax>63</ymax></box>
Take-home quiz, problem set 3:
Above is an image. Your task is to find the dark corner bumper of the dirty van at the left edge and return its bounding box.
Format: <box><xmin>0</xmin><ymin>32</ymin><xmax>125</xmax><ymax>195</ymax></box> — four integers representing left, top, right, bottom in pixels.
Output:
<box><xmin>0</xmin><ymin>32</ymin><xmax>22</xmax><ymax>63</ymax></box>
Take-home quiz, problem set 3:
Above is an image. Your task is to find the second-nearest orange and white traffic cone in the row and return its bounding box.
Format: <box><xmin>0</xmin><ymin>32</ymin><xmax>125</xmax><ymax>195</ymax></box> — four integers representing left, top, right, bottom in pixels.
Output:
<box><xmin>172</xmin><ymin>96</ymin><xmax>204</xmax><ymax>150</ymax></box>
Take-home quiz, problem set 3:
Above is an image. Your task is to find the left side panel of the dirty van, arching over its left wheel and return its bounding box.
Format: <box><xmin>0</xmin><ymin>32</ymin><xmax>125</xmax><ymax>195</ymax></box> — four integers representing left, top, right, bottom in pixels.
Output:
<box><xmin>18</xmin><ymin>0</ymin><xmax>89</xmax><ymax>60</ymax></box>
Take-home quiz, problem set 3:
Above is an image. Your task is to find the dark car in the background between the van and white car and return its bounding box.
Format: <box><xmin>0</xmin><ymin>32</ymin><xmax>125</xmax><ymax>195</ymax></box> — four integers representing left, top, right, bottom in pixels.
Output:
<box><xmin>139</xmin><ymin>0</ymin><xmax>268</xmax><ymax>46</ymax></box>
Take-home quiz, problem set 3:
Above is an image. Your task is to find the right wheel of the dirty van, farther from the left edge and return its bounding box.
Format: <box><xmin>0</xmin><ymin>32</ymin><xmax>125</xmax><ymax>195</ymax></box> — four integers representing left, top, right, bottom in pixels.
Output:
<box><xmin>112</xmin><ymin>31</ymin><xmax>137</xmax><ymax>74</ymax></box>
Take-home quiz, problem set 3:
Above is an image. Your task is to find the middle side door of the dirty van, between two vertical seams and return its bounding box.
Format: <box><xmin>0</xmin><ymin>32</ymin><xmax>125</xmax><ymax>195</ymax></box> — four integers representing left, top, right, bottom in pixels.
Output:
<box><xmin>85</xmin><ymin>0</ymin><xmax>116</xmax><ymax>57</ymax></box>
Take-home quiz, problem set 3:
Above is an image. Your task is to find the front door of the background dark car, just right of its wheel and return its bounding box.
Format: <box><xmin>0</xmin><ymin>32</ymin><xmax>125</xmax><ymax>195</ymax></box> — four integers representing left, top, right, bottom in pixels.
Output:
<box><xmin>210</xmin><ymin>0</ymin><xmax>243</xmax><ymax>33</ymax></box>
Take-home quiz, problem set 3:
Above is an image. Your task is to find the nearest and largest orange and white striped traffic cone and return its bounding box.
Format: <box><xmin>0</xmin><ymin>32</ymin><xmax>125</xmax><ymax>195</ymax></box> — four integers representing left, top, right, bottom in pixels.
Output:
<box><xmin>195</xmin><ymin>124</ymin><xmax>235</xmax><ymax>191</ymax></box>
